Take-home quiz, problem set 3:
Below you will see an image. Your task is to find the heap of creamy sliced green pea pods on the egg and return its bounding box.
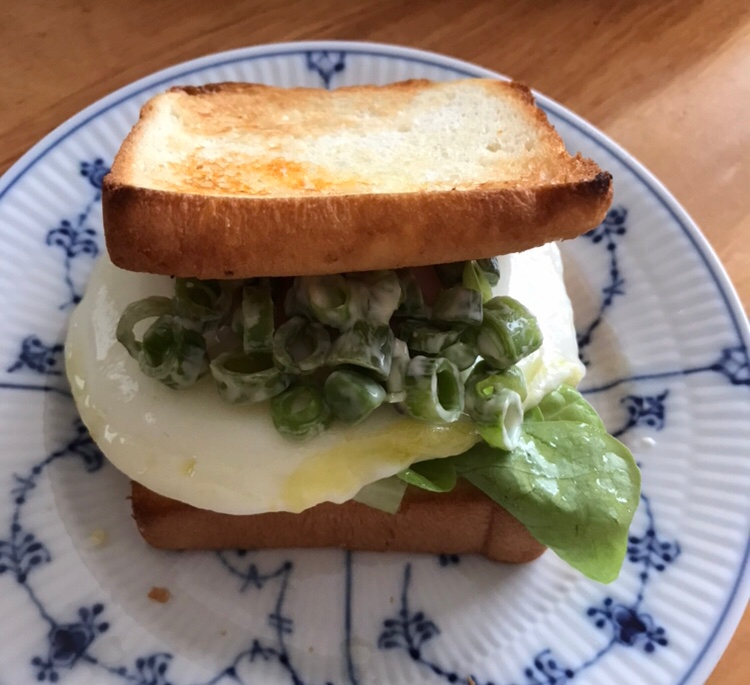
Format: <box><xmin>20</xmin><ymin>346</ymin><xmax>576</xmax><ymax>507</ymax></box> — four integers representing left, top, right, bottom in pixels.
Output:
<box><xmin>117</xmin><ymin>254</ymin><xmax>542</xmax><ymax>449</ymax></box>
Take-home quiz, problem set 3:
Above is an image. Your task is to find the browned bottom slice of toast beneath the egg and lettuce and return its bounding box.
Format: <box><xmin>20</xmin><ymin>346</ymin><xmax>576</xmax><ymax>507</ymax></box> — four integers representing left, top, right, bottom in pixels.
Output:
<box><xmin>131</xmin><ymin>481</ymin><xmax>545</xmax><ymax>564</ymax></box>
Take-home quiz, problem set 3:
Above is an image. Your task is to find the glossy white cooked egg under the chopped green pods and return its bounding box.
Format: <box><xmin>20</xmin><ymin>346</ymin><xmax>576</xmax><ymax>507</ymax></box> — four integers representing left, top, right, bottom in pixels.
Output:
<box><xmin>65</xmin><ymin>245</ymin><xmax>584</xmax><ymax>514</ymax></box>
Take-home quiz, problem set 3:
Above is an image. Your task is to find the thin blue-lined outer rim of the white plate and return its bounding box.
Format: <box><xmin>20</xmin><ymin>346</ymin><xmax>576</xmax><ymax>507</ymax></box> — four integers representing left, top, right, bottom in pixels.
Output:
<box><xmin>0</xmin><ymin>40</ymin><xmax>750</xmax><ymax>685</ymax></box>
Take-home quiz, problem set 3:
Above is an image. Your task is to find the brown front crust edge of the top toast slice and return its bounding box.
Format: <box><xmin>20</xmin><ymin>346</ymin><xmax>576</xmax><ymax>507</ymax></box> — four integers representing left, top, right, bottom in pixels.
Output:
<box><xmin>103</xmin><ymin>175</ymin><xmax>612</xmax><ymax>278</ymax></box>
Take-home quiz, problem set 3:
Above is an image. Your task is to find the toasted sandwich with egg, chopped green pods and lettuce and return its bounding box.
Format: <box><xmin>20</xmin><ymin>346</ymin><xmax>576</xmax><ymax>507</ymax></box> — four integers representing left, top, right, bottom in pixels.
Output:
<box><xmin>66</xmin><ymin>79</ymin><xmax>640</xmax><ymax>582</ymax></box>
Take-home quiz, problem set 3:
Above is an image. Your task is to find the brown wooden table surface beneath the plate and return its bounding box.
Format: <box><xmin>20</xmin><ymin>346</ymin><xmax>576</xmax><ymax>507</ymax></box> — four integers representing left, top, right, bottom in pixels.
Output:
<box><xmin>0</xmin><ymin>0</ymin><xmax>750</xmax><ymax>685</ymax></box>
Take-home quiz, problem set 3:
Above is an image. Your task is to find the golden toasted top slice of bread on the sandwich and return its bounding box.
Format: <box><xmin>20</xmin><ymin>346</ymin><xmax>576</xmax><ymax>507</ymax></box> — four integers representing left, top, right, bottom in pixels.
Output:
<box><xmin>103</xmin><ymin>79</ymin><xmax>611</xmax><ymax>278</ymax></box>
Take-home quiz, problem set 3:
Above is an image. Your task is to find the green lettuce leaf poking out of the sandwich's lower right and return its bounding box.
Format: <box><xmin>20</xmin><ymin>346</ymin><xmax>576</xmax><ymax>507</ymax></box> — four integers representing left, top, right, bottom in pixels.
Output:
<box><xmin>401</xmin><ymin>386</ymin><xmax>641</xmax><ymax>583</ymax></box>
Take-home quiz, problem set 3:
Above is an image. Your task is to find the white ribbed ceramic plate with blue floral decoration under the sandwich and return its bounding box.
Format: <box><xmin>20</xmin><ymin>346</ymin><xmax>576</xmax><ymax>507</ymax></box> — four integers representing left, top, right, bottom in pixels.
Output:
<box><xmin>0</xmin><ymin>43</ymin><xmax>750</xmax><ymax>685</ymax></box>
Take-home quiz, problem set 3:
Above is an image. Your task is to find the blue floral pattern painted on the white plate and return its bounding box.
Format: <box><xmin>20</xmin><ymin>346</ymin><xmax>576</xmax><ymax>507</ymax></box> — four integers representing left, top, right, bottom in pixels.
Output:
<box><xmin>0</xmin><ymin>44</ymin><xmax>750</xmax><ymax>685</ymax></box>
